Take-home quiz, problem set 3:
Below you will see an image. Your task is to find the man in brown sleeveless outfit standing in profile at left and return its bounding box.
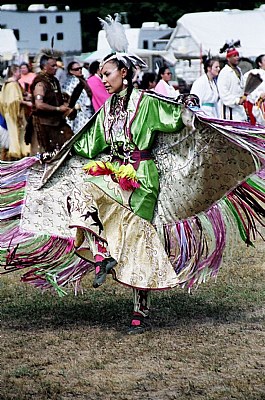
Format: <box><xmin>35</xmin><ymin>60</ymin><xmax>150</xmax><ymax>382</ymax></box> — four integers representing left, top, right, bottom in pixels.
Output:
<box><xmin>26</xmin><ymin>52</ymin><xmax>73</xmax><ymax>155</ymax></box>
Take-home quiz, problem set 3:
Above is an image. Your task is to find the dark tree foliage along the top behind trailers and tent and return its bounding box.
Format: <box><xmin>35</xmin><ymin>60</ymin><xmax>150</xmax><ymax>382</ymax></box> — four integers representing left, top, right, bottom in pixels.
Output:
<box><xmin>14</xmin><ymin>0</ymin><xmax>262</xmax><ymax>52</ymax></box>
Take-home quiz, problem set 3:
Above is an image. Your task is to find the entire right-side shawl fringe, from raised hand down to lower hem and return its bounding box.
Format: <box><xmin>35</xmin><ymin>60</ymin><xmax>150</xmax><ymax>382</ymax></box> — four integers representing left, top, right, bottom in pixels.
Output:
<box><xmin>156</xmin><ymin>107</ymin><xmax>265</xmax><ymax>289</ymax></box>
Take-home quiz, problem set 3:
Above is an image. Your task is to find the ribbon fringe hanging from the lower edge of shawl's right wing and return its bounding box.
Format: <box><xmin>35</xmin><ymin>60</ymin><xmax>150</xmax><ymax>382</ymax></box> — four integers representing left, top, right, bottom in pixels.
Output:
<box><xmin>159</xmin><ymin>169</ymin><xmax>265</xmax><ymax>289</ymax></box>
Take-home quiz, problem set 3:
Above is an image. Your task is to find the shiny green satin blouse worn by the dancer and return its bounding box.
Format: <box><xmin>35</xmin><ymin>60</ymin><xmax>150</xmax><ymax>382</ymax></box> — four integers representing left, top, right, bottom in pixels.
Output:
<box><xmin>74</xmin><ymin>89</ymin><xmax>184</xmax><ymax>221</ymax></box>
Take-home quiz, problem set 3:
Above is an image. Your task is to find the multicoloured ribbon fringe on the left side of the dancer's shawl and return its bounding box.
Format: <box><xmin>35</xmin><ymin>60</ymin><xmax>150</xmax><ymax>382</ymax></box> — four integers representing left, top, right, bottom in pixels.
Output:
<box><xmin>0</xmin><ymin>157</ymin><xmax>94</xmax><ymax>295</ymax></box>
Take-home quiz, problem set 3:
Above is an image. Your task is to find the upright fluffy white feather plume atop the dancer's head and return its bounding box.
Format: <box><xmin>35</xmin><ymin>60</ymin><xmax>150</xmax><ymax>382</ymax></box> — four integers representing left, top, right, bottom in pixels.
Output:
<box><xmin>98</xmin><ymin>13</ymin><xmax>128</xmax><ymax>53</ymax></box>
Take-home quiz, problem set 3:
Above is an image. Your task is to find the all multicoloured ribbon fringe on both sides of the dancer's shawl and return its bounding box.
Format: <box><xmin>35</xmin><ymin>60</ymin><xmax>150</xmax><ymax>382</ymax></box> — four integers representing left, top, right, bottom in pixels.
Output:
<box><xmin>0</xmin><ymin>113</ymin><xmax>265</xmax><ymax>295</ymax></box>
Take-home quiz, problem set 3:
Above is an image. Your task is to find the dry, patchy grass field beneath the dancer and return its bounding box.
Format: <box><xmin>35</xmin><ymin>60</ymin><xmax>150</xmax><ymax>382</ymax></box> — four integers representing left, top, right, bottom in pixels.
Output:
<box><xmin>0</xmin><ymin>241</ymin><xmax>265</xmax><ymax>400</ymax></box>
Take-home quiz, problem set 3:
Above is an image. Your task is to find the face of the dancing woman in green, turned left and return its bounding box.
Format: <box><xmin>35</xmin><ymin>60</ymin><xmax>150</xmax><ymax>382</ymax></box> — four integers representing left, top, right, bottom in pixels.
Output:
<box><xmin>101</xmin><ymin>61</ymin><xmax>127</xmax><ymax>94</ymax></box>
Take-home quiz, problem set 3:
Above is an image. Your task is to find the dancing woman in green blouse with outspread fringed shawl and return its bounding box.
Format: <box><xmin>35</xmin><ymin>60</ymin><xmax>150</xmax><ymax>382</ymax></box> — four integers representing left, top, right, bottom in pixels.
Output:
<box><xmin>0</xmin><ymin>15</ymin><xmax>265</xmax><ymax>333</ymax></box>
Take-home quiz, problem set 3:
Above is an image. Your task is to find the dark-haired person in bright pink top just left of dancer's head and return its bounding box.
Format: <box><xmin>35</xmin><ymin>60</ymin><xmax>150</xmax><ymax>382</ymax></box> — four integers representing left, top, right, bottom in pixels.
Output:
<box><xmin>87</xmin><ymin>61</ymin><xmax>110</xmax><ymax>111</ymax></box>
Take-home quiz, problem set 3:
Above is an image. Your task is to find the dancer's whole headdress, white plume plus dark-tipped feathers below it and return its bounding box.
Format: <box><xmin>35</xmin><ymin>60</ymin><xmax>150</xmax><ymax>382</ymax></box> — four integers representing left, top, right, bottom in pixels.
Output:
<box><xmin>98</xmin><ymin>13</ymin><xmax>147</xmax><ymax>68</ymax></box>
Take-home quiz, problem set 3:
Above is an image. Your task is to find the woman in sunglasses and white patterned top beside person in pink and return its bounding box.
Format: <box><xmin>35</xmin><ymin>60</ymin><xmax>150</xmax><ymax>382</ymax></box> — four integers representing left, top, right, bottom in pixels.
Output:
<box><xmin>62</xmin><ymin>61</ymin><xmax>94</xmax><ymax>133</ymax></box>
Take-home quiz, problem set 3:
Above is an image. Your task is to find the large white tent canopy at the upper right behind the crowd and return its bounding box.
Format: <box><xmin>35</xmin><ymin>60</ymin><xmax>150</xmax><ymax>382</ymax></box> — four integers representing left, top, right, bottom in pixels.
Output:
<box><xmin>166</xmin><ymin>5</ymin><xmax>265</xmax><ymax>60</ymax></box>
